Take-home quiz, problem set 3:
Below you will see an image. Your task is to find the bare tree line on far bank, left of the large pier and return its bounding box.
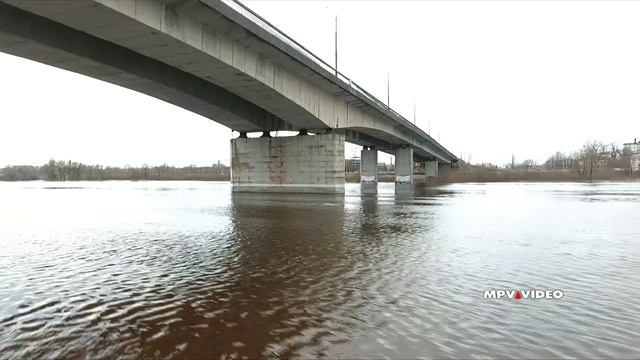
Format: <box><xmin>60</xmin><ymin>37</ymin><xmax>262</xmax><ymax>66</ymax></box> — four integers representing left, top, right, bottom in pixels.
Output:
<box><xmin>0</xmin><ymin>160</ymin><xmax>230</xmax><ymax>181</ymax></box>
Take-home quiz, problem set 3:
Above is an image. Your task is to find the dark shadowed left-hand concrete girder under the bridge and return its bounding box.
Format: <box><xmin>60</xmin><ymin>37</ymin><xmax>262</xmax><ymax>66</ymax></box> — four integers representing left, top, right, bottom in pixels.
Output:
<box><xmin>0</xmin><ymin>2</ymin><xmax>291</xmax><ymax>129</ymax></box>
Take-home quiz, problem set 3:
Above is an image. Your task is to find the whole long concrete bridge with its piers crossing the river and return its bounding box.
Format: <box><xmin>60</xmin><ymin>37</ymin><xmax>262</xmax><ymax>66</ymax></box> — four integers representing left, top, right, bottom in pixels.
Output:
<box><xmin>0</xmin><ymin>0</ymin><xmax>457</xmax><ymax>193</ymax></box>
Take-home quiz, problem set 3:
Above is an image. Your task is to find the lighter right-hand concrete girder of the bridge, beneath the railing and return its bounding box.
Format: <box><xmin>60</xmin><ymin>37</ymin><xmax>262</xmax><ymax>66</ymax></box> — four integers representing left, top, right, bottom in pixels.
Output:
<box><xmin>4</xmin><ymin>0</ymin><xmax>452</xmax><ymax>162</ymax></box>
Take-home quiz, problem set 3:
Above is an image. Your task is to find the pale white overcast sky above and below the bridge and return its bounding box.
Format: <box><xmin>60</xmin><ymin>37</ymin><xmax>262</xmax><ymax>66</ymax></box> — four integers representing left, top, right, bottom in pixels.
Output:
<box><xmin>0</xmin><ymin>1</ymin><xmax>640</xmax><ymax>166</ymax></box>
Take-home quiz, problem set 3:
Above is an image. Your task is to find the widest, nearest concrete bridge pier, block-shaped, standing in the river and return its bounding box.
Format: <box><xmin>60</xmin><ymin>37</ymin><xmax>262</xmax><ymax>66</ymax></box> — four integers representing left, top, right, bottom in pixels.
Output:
<box><xmin>231</xmin><ymin>132</ymin><xmax>344</xmax><ymax>193</ymax></box>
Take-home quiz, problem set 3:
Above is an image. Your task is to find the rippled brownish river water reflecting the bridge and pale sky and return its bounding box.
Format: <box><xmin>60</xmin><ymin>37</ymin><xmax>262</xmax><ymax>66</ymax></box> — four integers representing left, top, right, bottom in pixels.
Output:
<box><xmin>0</xmin><ymin>182</ymin><xmax>640</xmax><ymax>359</ymax></box>
